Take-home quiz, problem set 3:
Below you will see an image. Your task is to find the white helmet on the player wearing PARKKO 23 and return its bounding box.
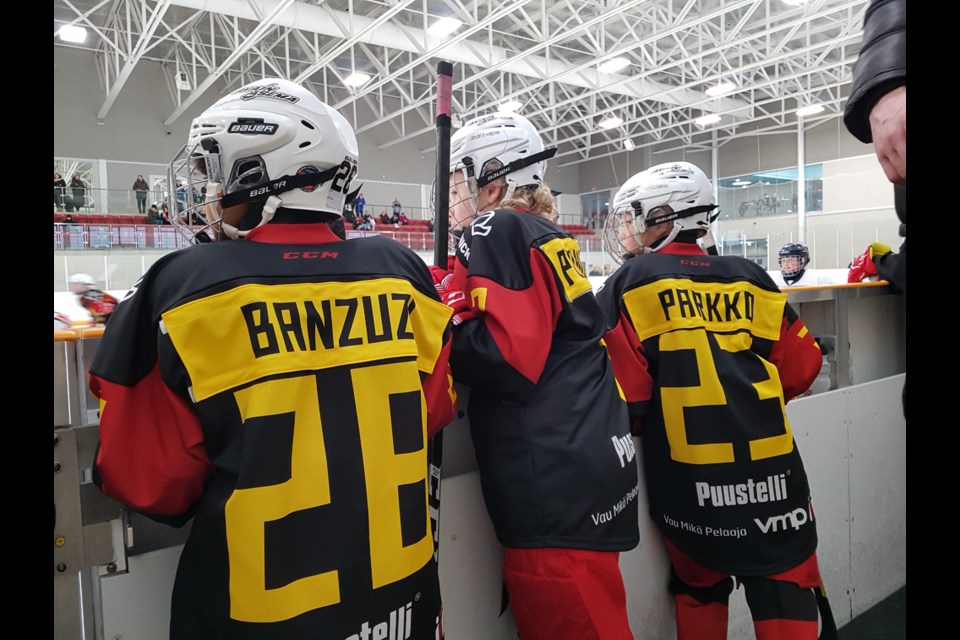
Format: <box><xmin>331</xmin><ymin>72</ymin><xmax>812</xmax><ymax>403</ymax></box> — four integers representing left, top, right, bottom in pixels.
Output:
<box><xmin>603</xmin><ymin>162</ymin><xmax>720</xmax><ymax>263</ymax></box>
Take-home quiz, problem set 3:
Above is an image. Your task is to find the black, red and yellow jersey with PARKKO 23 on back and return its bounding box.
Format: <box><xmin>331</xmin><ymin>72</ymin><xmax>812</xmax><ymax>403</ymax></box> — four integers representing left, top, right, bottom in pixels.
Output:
<box><xmin>597</xmin><ymin>242</ymin><xmax>822</xmax><ymax>576</ymax></box>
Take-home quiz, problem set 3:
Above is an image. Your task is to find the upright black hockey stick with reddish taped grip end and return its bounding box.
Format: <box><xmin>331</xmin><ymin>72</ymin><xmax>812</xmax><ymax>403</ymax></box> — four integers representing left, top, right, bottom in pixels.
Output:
<box><xmin>427</xmin><ymin>61</ymin><xmax>453</xmax><ymax>560</ymax></box>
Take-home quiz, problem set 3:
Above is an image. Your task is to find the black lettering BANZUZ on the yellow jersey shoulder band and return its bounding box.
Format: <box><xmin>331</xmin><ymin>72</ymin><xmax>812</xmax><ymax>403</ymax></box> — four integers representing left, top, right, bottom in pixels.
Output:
<box><xmin>240</xmin><ymin>293</ymin><xmax>415</xmax><ymax>358</ymax></box>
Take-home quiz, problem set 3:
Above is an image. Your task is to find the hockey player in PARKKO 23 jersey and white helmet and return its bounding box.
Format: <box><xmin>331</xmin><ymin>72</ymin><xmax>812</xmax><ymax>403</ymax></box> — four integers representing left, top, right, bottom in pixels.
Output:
<box><xmin>597</xmin><ymin>162</ymin><xmax>832</xmax><ymax>640</ymax></box>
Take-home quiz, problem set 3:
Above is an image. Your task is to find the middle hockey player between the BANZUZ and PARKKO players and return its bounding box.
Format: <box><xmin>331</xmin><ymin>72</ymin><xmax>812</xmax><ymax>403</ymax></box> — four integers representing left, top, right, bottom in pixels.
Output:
<box><xmin>441</xmin><ymin>113</ymin><xmax>639</xmax><ymax>640</ymax></box>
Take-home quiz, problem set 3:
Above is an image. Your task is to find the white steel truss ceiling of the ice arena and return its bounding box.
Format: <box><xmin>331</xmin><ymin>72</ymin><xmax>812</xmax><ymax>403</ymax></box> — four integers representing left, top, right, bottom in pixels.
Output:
<box><xmin>54</xmin><ymin>0</ymin><xmax>868</xmax><ymax>166</ymax></box>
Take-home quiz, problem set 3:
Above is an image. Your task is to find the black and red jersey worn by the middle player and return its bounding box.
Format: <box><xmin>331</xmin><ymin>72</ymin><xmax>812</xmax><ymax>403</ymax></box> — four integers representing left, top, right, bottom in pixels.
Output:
<box><xmin>451</xmin><ymin>210</ymin><xmax>639</xmax><ymax>551</ymax></box>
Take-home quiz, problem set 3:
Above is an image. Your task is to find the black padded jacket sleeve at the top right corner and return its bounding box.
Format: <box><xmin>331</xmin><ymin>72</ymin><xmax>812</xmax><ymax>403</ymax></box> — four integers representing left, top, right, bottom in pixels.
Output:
<box><xmin>843</xmin><ymin>0</ymin><xmax>907</xmax><ymax>142</ymax></box>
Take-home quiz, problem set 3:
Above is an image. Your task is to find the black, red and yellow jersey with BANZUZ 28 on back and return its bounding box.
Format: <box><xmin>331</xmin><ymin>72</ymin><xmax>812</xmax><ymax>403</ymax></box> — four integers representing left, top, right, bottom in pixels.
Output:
<box><xmin>90</xmin><ymin>224</ymin><xmax>456</xmax><ymax>640</ymax></box>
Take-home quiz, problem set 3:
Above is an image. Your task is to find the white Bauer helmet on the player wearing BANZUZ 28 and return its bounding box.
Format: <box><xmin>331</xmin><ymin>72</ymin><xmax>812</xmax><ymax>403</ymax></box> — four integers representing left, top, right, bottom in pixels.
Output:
<box><xmin>168</xmin><ymin>78</ymin><xmax>358</xmax><ymax>241</ymax></box>
